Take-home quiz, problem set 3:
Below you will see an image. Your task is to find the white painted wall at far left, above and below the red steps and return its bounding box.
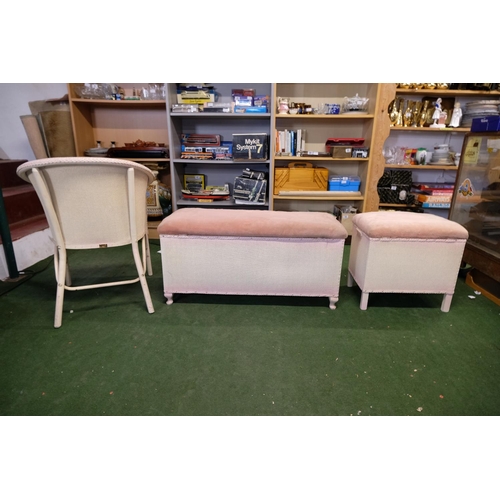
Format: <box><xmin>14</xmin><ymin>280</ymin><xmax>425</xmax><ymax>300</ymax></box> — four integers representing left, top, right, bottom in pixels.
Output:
<box><xmin>0</xmin><ymin>83</ymin><xmax>67</xmax><ymax>280</ymax></box>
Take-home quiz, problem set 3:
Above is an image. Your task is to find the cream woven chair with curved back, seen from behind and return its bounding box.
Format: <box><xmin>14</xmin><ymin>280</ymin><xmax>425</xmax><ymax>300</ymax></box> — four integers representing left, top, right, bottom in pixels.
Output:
<box><xmin>17</xmin><ymin>157</ymin><xmax>154</xmax><ymax>328</ymax></box>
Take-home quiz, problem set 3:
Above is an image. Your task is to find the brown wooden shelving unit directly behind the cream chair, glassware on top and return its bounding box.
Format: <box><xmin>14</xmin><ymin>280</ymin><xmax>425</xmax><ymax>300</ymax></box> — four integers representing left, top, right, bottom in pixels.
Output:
<box><xmin>68</xmin><ymin>83</ymin><xmax>168</xmax><ymax>161</ymax></box>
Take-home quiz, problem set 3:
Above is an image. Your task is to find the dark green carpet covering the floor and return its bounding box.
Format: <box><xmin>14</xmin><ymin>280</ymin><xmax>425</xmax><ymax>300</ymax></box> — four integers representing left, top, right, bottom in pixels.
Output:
<box><xmin>0</xmin><ymin>240</ymin><xmax>500</xmax><ymax>416</ymax></box>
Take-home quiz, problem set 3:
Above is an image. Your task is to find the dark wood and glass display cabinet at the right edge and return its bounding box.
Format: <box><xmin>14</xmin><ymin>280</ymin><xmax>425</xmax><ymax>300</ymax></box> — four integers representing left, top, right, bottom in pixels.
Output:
<box><xmin>449</xmin><ymin>132</ymin><xmax>500</xmax><ymax>305</ymax></box>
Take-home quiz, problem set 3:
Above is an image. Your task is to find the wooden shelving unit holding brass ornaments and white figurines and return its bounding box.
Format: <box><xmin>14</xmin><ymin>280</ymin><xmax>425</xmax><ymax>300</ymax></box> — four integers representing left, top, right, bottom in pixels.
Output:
<box><xmin>380</xmin><ymin>84</ymin><xmax>500</xmax><ymax>217</ymax></box>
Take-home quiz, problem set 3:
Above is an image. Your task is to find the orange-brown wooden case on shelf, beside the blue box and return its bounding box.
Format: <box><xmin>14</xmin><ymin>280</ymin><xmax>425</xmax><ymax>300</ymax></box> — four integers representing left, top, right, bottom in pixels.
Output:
<box><xmin>274</xmin><ymin>162</ymin><xmax>328</xmax><ymax>194</ymax></box>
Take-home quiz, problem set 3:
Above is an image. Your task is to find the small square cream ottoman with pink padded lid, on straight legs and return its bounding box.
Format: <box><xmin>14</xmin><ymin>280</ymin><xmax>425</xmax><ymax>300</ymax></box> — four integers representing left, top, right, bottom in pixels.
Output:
<box><xmin>347</xmin><ymin>212</ymin><xmax>469</xmax><ymax>312</ymax></box>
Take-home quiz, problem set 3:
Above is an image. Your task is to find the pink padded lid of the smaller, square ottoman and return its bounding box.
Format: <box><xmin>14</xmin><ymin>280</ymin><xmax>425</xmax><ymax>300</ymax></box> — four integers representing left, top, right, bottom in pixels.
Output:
<box><xmin>352</xmin><ymin>212</ymin><xmax>469</xmax><ymax>240</ymax></box>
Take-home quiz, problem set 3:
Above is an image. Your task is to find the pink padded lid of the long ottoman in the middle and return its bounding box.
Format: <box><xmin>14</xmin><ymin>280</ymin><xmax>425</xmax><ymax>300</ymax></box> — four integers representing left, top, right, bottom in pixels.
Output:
<box><xmin>158</xmin><ymin>208</ymin><xmax>347</xmax><ymax>239</ymax></box>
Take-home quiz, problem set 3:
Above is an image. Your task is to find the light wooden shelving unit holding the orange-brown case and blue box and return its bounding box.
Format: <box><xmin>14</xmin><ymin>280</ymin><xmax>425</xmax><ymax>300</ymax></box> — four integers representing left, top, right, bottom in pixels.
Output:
<box><xmin>271</xmin><ymin>83</ymin><xmax>391</xmax><ymax>212</ymax></box>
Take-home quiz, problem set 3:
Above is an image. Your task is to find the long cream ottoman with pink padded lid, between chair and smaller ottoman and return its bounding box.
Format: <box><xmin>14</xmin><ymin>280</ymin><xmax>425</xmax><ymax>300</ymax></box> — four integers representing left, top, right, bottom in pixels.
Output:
<box><xmin>158</xmin><ymin>208</ymin><xmax>347</xmax><ymax>309</ymax></box>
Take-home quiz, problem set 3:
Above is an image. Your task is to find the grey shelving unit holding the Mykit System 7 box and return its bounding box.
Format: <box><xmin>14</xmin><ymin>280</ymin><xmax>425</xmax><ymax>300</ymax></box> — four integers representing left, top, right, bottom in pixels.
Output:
<box><xmin>167</xmin><ymin>83</ymin><xmax>274</xmax><ymax>210</ymax></box>
